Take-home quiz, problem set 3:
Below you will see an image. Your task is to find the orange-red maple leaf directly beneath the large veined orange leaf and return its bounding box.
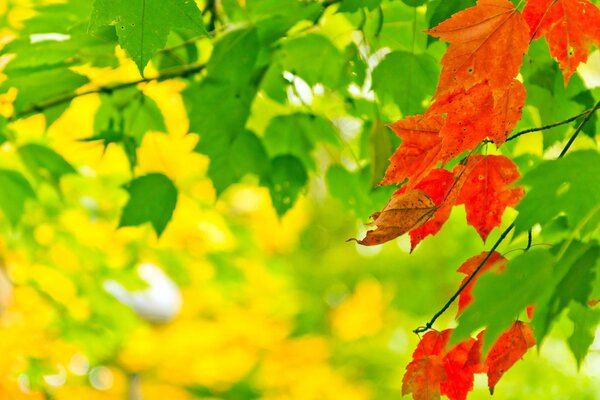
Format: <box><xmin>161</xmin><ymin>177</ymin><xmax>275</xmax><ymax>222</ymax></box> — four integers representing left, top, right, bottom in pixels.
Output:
<box><xmin>428</xmin><ymin>80</ymin><xmax>526</xmax><ymax>163</ymax></box>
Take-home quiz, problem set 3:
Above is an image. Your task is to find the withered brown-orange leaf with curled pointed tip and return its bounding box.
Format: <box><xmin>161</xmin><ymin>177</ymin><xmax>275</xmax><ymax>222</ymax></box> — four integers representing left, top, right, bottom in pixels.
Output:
<box><xmin>349</xmin><ymin>189</ymin><xmax>438</xmax><ymax>246</ymax></box>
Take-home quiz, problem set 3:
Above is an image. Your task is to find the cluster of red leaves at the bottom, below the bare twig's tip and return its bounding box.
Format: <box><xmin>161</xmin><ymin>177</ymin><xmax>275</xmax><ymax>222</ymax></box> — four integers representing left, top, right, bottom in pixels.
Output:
<box><xmin>402</xmin><ymin>321</ymin><xmax>535</xmax><ymax>400</ymax></box>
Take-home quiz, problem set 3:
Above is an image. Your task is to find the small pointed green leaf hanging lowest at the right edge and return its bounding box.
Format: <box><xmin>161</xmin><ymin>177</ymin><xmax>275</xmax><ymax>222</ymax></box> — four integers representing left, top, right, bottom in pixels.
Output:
<box><xmin>567</xmin><ymin>302</ymin><xmax>600</xmax><ymax>367</ymax></box>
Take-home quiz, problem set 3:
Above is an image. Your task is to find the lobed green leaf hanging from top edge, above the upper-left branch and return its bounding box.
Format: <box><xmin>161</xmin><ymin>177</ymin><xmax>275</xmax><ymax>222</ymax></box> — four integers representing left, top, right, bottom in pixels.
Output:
<box><xmin>89</xmin><ymin>0</ymin><xmax>206</xmax><ymax>75</ymax></box>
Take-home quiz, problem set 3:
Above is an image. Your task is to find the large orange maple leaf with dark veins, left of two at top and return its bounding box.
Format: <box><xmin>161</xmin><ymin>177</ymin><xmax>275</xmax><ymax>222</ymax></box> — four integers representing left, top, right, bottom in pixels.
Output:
<box><xmin>427</xmin><ymin>0</ymin><xmax>529</xmax><ymax>94</ymax></box>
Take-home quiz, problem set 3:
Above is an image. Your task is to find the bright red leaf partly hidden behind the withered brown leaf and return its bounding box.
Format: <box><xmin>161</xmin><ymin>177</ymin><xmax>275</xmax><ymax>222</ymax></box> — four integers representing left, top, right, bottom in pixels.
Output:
<box><xmin>409</xmin><ymin>168</ymin><xmax>455</xmax><ymax>251</ymax></box>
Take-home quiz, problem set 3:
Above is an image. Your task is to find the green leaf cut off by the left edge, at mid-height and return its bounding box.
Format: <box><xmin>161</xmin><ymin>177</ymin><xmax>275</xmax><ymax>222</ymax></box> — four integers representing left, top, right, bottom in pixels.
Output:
<box><xmin>0</xmin><ymin>169</ymin><xmax>35</xmax><ymax>227</ymax></box>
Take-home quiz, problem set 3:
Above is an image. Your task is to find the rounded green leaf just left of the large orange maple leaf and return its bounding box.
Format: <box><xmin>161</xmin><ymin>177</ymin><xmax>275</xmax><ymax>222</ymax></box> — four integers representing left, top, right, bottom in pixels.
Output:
<box><xmin>373</xmin><ymin>51</ymin><xmax>440</xmax><ymax>115</ymax></box>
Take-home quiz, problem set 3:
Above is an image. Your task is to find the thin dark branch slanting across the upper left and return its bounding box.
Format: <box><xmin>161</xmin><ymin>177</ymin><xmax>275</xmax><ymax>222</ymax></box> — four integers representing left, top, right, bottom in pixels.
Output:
<box><xmin>8</xmin><ymin>64</ymin><xmax>206</xmax><ymax>122</ymax></box>
